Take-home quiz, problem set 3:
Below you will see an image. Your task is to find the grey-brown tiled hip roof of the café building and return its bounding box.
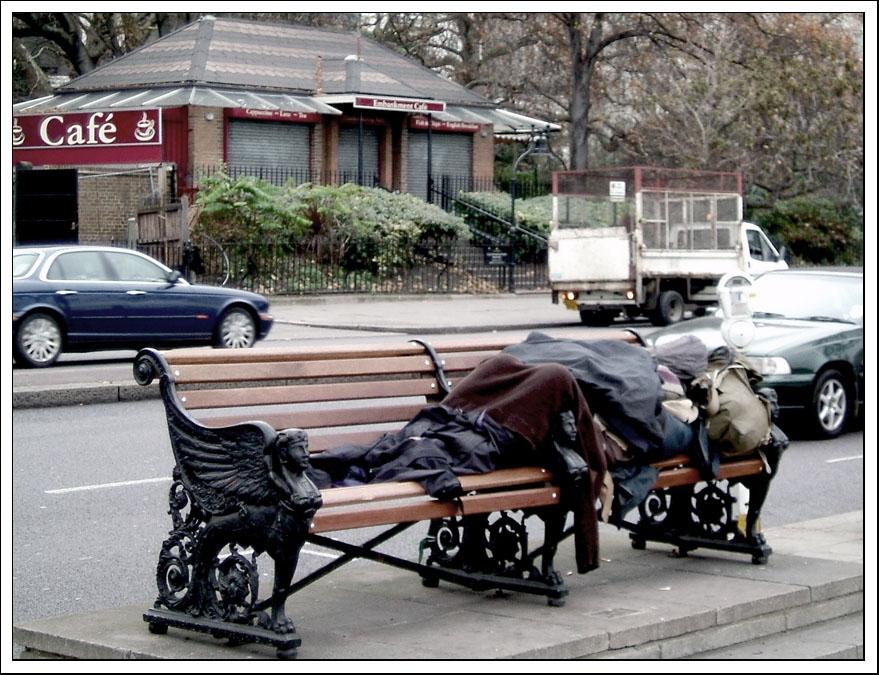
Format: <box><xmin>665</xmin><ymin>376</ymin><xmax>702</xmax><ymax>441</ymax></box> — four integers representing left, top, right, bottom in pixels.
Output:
<box><xmin>58</xmin><ymin>17</ymin><xmax>491</xmax><ymax>106</ymax></box>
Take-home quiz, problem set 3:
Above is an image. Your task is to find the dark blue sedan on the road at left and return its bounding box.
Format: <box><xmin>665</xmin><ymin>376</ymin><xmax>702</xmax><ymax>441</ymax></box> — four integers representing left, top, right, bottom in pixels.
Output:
<box><xmin>12</xmin><ymin>245</ymin><xmax>272</xmax><ymax>367</ymax></box>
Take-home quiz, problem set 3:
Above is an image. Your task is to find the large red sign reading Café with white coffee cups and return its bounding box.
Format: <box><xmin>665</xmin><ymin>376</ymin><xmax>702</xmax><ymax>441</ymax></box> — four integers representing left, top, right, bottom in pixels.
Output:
<box><xmin>12</xmin><ymin>108</ymin><xmax>162</xmax><ymax>163</ymax></box>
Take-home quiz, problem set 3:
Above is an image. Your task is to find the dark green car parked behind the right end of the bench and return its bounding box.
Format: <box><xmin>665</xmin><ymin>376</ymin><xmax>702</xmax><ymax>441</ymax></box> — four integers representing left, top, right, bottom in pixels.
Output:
<box><xmin>644</xmin><ymin>270</ymin><xmax>864</xmax><ymax>438</ymax></box>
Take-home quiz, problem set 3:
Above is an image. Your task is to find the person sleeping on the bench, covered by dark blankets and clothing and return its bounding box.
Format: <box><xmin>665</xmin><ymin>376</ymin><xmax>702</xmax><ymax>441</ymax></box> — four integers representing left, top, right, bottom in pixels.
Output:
<box><xmin>308</xmin><ymin>333</ymin><xmax>784</xmax><ymax>573</ymax></box>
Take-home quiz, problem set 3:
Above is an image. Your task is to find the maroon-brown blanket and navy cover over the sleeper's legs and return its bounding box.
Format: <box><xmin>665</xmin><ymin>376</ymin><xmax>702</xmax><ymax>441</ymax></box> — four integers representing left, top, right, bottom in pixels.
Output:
<box><xmin>309</xmin><ymin>354</ymin><xmax>607</xmax><ymax>573</ymax></box>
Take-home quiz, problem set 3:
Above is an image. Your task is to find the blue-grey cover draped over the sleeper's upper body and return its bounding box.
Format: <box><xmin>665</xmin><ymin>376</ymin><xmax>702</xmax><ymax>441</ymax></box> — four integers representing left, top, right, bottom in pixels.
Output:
<box><xmin>501</xmin><ymin>332</ymin><xmax>665</xmax><ymax>458</ymax></box>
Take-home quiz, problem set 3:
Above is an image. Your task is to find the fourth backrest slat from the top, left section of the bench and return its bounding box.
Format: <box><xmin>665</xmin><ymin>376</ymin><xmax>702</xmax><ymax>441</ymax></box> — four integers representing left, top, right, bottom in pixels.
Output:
<box><xmin>198</xmin><ymin>403</ymin><xmax>434</xmax><ymax>430</ymax></box>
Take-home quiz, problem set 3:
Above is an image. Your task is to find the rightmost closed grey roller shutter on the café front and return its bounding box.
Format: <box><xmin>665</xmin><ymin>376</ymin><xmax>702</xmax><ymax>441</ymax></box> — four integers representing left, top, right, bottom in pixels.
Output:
<box><xmin>406</xmin><ymin>130</ymin><xmax>473</xmax><ymax>200</ymax></box>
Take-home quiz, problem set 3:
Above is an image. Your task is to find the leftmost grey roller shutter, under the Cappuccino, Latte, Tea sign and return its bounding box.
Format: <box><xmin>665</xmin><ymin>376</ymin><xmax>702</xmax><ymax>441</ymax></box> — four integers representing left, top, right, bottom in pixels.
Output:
<box><xmin>227</xmin><ymin>120</ymin><xmax>311</xmax><ymax>185</ymax></box>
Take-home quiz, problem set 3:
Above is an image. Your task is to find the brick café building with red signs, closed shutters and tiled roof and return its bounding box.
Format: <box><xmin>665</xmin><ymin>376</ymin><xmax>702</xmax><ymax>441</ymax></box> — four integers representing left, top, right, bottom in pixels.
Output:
<box><xmin>12</xmin><ymin>16</ymin><xmax>559</xmax><ymax>244</ymax></box>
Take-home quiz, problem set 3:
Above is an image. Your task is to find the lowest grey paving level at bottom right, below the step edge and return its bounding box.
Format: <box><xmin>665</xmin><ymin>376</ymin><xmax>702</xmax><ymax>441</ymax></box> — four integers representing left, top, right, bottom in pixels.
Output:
<box><xmin>689</xmin><ymin>612</ymin><xmax>864</xmax><ymax>660</ymax></box>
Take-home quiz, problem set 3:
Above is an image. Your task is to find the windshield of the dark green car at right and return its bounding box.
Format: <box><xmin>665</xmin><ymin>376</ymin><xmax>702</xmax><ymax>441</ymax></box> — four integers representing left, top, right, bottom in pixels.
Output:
<box><xmin>750</xmin><ymin>272</ymin><xmax>864</xmax><ymax>323</ymax></box>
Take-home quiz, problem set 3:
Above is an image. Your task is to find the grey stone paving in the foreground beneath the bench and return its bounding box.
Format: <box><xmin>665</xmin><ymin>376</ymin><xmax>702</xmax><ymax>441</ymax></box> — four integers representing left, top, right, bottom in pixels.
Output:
<box><xmin>13</xmin><ymin>512</ymin><xmax>875</xmax><ymax>660</ymax></box>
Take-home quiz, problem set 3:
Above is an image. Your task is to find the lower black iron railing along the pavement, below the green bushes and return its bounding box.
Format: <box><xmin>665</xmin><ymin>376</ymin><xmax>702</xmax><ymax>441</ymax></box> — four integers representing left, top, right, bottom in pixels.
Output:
<box><xmin>129</xmin><ymin>238</ymin><xmax>549</xmax><ymax>295</ymax></box>
